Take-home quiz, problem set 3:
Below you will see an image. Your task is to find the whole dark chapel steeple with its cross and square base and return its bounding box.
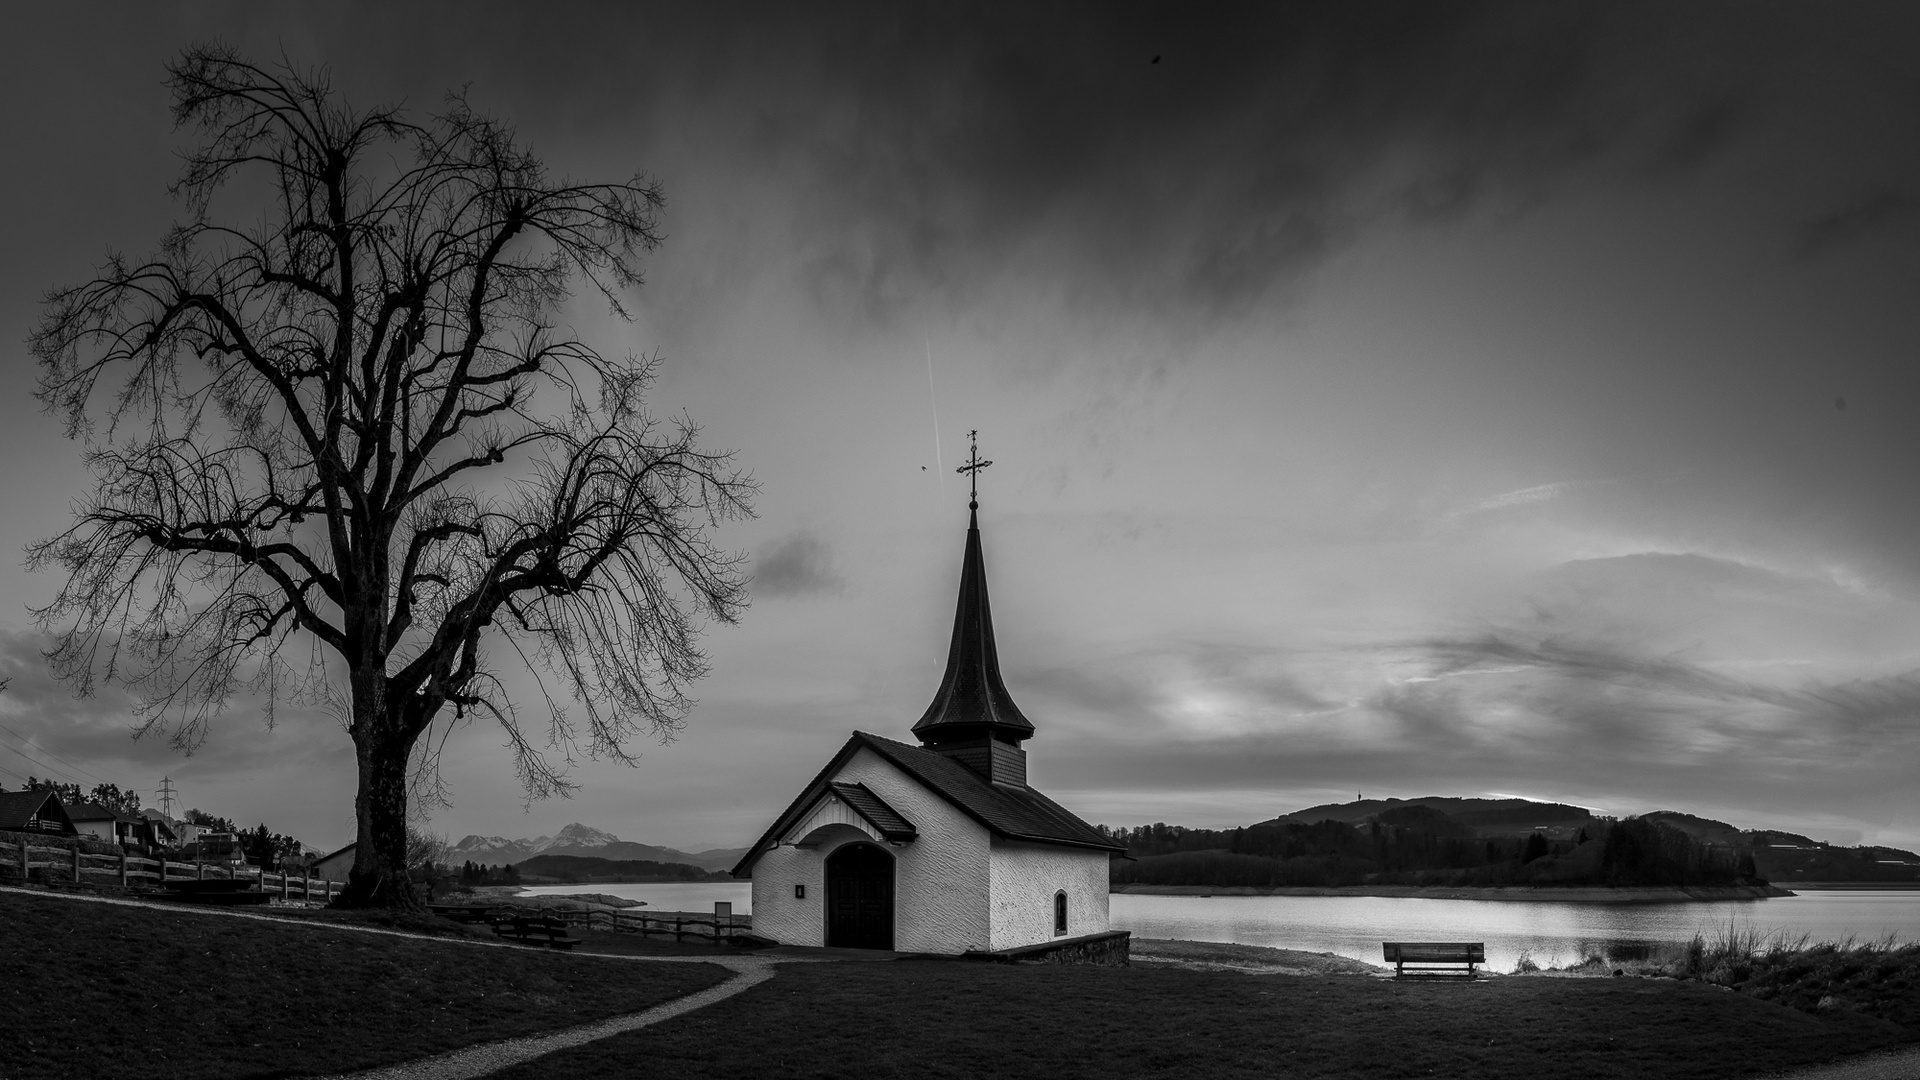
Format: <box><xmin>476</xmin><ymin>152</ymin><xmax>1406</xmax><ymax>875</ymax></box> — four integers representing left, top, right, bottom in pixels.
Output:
<box><xmin>914</xmin><ymin>432</ymin><xmax>1033</xmax><ymax>788</ymax></box>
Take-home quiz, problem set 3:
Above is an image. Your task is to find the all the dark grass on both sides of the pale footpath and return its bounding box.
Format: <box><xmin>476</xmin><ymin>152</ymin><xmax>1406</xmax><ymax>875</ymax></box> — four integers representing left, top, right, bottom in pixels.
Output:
<box><xmin>0</xmin><ymin>894</ymin><xmax>1920</xmax><ymax>1080</ymax></box>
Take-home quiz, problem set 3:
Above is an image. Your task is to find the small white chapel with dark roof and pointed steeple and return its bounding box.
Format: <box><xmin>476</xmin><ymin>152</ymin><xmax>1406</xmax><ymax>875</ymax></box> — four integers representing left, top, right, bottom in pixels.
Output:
<box><xmin>733</xmin><ymin>488</ymin><xmax>1125</xmax><ymax>955</ymax></box>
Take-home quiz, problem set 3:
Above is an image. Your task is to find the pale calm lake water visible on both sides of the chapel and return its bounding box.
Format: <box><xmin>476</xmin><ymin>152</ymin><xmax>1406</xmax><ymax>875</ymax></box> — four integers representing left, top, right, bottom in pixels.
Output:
<box><xmin>524</xmin><ymin>882</ymin><xmax>1920</xmax><ymax>970</ymax></box>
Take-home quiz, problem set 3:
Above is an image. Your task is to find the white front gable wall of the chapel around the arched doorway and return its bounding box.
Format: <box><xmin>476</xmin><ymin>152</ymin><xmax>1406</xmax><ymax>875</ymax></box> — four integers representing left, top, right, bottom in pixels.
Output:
<box><xmin>751</xmin><ymin>748</ymin><xmax>998</xmax><ymax>953</ymax></box>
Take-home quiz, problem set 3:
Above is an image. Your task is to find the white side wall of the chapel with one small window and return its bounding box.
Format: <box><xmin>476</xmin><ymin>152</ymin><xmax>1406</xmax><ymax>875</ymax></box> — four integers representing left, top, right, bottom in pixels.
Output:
<box><xmin>991</xmin><ymin>840</ymin><xmax>1108</xmax><ymax>949</ymax></box>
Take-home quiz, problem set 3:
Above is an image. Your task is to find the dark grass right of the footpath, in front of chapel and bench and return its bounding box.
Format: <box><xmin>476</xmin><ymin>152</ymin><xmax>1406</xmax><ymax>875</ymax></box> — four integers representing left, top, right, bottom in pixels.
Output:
<box><xmin>487</xmin><ymin>961</ymin><xmax>1916</xmax><ymax>1080</ymax></box>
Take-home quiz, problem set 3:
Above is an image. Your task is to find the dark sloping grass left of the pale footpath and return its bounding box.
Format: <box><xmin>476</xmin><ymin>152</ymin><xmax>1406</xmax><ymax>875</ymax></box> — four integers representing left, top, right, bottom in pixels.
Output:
<box><xmin>0</xmin><ymin>894</ymin><xmax>730</xmax><ymax>1080</ymax></box>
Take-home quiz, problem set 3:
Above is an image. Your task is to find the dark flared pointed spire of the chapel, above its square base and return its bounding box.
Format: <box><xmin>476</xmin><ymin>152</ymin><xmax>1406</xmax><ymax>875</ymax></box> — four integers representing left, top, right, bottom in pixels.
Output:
<box><xmin>914</xmin><ymin>448</ymin><xmax>1033</xmax><ymax>745</ymax></box>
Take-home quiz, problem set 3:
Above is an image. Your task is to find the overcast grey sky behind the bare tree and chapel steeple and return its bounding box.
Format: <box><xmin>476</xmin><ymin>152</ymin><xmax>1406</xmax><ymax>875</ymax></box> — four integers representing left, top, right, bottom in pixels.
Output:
<box><xmin>0</xmin><ymin>4</ymin><xmax>1920</xmax><ymax>849</ymax></box>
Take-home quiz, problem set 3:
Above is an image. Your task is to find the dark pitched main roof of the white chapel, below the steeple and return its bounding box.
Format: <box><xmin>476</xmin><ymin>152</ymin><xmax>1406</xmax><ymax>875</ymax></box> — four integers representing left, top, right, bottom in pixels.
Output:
<box><xmin>732</xmin><ymin>732</ymin><xmax>1127</xmax><ymax>876</ymax></box>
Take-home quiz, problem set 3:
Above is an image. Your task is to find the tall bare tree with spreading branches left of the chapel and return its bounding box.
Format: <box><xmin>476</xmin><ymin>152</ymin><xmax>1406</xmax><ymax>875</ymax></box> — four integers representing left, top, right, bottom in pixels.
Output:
<box><xmin>29</xmin><ymin>44</ymin><xmax>753</xmax><ymax>907</ymax></box>
